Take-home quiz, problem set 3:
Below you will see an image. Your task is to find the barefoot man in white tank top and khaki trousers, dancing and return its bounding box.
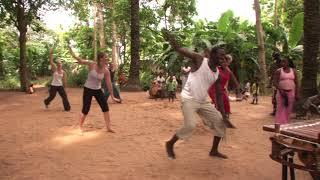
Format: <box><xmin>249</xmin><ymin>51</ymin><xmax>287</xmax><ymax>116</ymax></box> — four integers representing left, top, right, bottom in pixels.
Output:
<box><xmin>163</xmin><ymin>30</ymin><xmax>234</xmax><ymax>159</ymax></box>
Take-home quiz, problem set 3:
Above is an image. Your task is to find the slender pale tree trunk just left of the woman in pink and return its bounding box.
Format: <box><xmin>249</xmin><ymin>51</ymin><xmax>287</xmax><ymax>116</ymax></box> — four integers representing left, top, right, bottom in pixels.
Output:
<box><xmin>254</xmin><ymin>0</ymin><xmax>267</xmax><ymax>94</ymax></box>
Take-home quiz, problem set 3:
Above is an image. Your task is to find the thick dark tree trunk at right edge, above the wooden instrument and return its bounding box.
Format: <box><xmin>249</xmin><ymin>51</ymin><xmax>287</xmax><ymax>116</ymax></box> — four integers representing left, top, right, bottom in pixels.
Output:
<box><xmin>301</xmin><ymin>0</ymin><xmax>320</xmax><ymax>98</ymax></box>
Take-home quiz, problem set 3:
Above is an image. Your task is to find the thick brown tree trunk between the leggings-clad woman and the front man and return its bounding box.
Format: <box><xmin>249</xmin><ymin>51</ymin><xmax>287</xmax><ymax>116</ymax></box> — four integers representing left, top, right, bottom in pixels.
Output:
<box><xmin>126</xmin><ymin>0</ymin><xmax>141</xmax><ymax>91</ymax></box>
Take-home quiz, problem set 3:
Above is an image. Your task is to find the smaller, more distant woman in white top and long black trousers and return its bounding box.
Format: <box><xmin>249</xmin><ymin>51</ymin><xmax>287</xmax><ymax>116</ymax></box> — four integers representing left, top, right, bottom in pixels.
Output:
<box><xmin>44</xmin><ymin>48</ymin><xmax>71</xmax><ymax>111</ymax></box>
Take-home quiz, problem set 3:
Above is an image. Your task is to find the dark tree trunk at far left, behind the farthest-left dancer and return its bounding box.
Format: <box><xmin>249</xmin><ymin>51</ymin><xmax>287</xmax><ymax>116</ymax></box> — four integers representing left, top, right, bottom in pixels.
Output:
<box><xmin>17</xmin><ymin>1</ymin><xmax>29</xmax><ymax>91</ymax></box>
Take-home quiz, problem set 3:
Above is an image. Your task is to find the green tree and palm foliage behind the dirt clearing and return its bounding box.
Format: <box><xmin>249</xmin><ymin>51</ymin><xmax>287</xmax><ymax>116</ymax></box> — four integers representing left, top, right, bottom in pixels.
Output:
<box><xmin>0</xmin><ymin>0</ymin><xmax>310</xmax><ymax>89</ymax></box>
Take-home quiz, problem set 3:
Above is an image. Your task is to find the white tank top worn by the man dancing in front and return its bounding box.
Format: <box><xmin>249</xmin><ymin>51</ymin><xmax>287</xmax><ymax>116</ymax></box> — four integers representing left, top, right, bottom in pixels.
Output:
<box><xmin>181</xmin><ymin>58</ymin><xmax>219</xmax><ymax>101</ymax></box>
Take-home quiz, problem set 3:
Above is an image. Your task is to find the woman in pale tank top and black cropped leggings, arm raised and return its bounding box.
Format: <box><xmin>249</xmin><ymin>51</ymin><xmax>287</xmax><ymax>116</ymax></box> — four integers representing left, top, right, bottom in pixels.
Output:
<box><xmin>69</xmin><ymin>47</ymin><xmax>120</xmax><ymax>133</ymax></box>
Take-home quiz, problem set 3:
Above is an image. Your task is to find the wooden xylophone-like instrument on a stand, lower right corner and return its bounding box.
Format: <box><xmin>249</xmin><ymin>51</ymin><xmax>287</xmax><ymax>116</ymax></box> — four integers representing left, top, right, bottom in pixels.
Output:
<box><xmin>263</xmin><ymin>119</ymin><xmax>320</xmax><ymax>180</ymax></box>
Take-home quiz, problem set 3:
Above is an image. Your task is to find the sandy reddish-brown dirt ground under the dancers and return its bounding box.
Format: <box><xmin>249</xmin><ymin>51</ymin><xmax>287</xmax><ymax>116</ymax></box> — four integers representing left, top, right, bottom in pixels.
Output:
<box><xmin>0</xmin><ymin>88</ymin><xmax>311</xmax><ymax>180</ymax></box>
